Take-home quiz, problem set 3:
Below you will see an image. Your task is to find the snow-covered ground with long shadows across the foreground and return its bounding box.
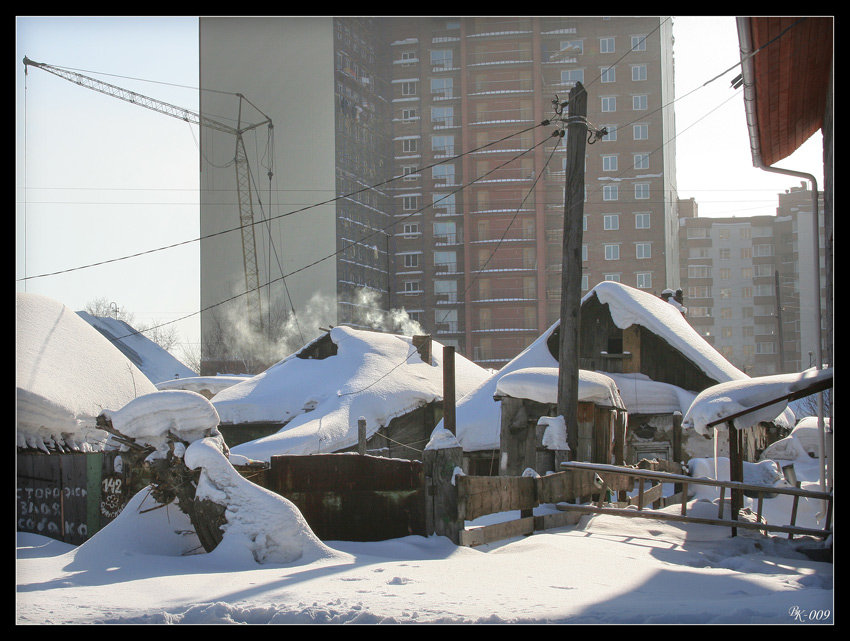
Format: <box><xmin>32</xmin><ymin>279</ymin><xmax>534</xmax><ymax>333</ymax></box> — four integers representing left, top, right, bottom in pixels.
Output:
<box><xmin>16</xmin><ymin>502</ymin><xmax>834</xmax><ymax>625</ymax></box>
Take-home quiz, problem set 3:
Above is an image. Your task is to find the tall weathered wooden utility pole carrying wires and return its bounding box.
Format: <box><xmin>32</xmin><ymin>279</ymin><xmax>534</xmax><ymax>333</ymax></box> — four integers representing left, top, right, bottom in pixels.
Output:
<box><xmin>558</xmin><ymin>82</ymin><xmax>587</xmax><ymax>458</ymax></box>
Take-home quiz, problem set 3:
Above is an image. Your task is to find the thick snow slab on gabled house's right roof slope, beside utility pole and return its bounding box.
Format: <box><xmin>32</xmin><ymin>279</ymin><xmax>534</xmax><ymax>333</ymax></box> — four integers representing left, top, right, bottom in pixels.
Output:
<box><xmin>582</xmin><ymin>281</ymin><xmax>749</xmax><ymax>382</ymax></box>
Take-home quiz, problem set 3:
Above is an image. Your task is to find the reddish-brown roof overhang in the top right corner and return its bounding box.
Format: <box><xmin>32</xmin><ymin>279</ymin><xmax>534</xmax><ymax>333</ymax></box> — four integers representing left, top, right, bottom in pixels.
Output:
<box><xmin>748</xmin><ymin>16</ymin><xmax>833</xmax><ymax>166</ymax></box>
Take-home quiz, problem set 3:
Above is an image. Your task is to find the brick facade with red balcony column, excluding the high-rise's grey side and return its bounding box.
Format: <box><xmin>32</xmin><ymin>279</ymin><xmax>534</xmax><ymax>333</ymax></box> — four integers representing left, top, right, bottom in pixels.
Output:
<box><xmin>382</xmin><ymin>16</ymin><xmax>678</xmax><ymax>368</ymax></box>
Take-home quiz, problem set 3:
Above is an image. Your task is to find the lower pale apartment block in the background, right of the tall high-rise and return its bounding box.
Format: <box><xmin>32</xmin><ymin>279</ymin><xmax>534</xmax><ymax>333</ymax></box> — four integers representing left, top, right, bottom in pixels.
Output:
<box><xmin>680</xmin><ymin>184</ymin><xmax>826</xmax><ymax>376</ymax></box>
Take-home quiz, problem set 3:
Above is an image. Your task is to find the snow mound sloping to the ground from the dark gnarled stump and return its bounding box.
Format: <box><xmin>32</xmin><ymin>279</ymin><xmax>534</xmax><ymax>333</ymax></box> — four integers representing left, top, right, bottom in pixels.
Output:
<box><xmin>184</xmin><ymin>439</ymin><xmax>348</xmax><ymax>565</ymax></box>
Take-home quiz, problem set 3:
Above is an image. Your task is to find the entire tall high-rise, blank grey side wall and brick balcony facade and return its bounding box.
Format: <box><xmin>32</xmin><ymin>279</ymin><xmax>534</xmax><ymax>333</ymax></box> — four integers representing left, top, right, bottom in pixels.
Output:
<box><xmin>200</xmin><ymin>16</ymin><xmax>679</xmax><ymax>371</ymax></box>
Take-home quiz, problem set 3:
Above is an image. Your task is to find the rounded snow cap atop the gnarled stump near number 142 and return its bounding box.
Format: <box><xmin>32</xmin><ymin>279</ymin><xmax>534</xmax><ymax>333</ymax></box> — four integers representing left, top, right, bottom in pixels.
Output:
<box><xmin>103</xmin><ymin>390</ymin><xmax>224</xmax><ymax>460</ymax></box>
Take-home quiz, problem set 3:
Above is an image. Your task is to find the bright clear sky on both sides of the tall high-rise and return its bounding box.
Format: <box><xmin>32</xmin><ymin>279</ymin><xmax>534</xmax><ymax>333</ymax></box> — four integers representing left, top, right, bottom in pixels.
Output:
<box><xmin>15</xmin><ymin>16</ymin><xmax>823</xmax><ymax>362</ymax></box>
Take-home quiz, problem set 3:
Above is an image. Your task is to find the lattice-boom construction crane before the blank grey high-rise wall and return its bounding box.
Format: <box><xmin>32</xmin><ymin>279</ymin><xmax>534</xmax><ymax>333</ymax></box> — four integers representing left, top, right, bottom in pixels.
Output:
<box><xmin>24</xmin><ymin>56</ymin><xmax>274</xmax><ymax>332</ymax></box>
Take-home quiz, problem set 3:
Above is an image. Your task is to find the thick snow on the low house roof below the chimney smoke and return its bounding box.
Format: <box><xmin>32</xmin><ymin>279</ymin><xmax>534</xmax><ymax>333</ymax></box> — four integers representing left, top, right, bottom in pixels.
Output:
<box><xmin>213</xmin><ymin>326</ymin><xmax>488</xmax><ymax>460</ymax></box>
